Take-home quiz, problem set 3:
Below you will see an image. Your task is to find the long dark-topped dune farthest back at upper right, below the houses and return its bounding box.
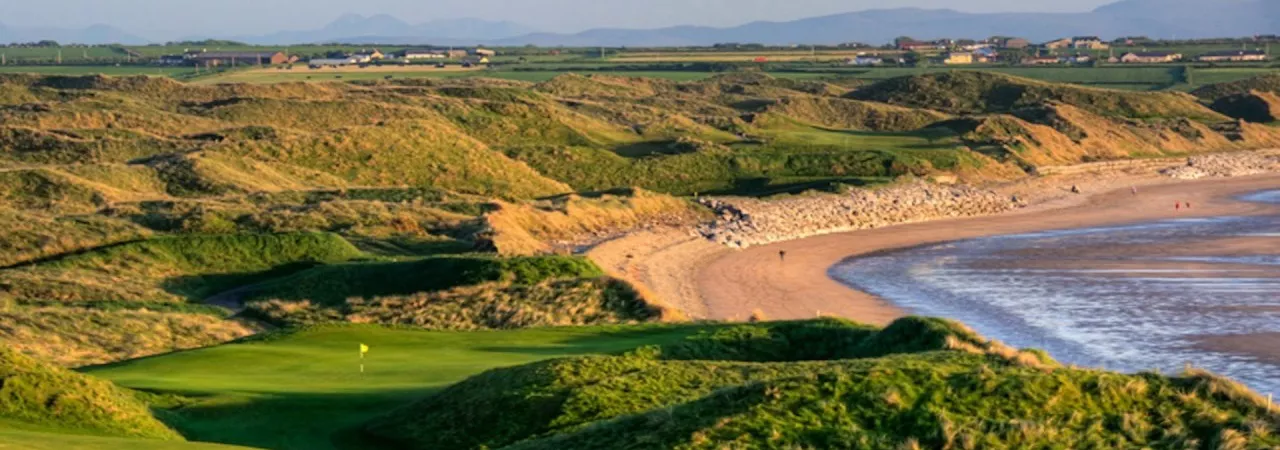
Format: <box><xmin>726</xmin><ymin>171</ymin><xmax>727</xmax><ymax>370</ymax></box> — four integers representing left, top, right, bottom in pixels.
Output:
<box><xmin>849</xmin><ymin>72</ymin><xmax>1226</xmax><ymax>121</ymax></box>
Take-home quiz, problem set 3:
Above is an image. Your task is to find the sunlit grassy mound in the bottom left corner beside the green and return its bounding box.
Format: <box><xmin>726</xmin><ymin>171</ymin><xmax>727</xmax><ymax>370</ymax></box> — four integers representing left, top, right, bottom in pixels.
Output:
<box><xmin>0</xmin><ymin>348</ymin><xmax>182</xmax><ymax>440</ymax></box>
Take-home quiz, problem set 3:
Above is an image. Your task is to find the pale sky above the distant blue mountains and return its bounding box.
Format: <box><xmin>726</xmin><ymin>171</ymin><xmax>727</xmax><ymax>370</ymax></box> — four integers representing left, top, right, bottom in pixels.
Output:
<box><xmin>0</xmin><ymin>0</ymin><xmax>1112</xmax><ymax>38</ymax></box>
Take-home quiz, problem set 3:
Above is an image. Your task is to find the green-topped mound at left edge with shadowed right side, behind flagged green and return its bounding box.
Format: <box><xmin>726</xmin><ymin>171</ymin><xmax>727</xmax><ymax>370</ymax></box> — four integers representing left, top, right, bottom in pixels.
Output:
<box><xmin>0</xmin><ymin>233</ymin><xmax>364</xmax><ymax>302</ymax></box>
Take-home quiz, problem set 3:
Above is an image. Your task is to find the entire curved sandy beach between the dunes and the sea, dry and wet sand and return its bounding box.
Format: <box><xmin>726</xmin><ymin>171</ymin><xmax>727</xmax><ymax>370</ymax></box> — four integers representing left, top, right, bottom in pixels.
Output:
<box><xmin>588</xmin><ymin>173</ymin><xmax>1280</xmax><ymax>325</ymax></box>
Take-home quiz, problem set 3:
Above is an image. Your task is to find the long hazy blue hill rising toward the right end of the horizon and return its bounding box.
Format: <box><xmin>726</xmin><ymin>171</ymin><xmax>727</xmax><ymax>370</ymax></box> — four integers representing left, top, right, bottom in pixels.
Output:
<box><xmin>488</xmin><ymin>0</ymin><xmax>1280</xmax><ymax>46</ymax></box>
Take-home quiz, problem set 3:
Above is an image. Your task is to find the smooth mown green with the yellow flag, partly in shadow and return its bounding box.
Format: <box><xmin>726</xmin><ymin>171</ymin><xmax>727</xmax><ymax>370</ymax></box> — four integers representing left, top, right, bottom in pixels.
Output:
<box><xmin>85</xmin><ymin>325</ymin><xmax>705</xmax><ymax>449</ymax></box>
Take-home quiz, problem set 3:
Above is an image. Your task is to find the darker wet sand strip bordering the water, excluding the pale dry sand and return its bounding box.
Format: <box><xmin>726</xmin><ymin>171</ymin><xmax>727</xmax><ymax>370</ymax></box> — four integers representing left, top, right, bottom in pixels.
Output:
<box><xmin>696</xmin><ymin>175</ymin><xmax>1280</xmax><ymax>325</ymax></box>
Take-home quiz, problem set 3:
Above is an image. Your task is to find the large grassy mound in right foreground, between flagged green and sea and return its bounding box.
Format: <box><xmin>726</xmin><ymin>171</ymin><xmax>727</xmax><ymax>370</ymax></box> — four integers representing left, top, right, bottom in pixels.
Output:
<box><xmin>366</xmin><ymin>318</ymin><xmax>1280</xmax><ymax>449</ymax></box>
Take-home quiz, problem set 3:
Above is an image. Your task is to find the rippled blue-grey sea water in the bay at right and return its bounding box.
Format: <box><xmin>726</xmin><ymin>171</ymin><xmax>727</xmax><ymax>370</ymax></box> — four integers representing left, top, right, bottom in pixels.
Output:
<box><xmin>831</xmin><ymin>190</ymin><xmax>1280</xmax><ymax>394</ymax></box>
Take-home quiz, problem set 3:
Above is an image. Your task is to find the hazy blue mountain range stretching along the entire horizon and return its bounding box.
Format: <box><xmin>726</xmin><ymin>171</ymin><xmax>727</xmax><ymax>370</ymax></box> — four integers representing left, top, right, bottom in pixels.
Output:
<box><xmin>0</xmin><ymin>0</ymin><xmax>1280</xmax><ymax>46</ymax></box>
